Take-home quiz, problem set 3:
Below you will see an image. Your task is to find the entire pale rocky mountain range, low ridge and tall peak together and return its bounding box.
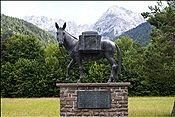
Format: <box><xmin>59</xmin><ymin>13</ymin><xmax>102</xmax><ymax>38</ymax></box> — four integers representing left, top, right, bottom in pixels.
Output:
<box><xmin>24</xmin><ymin>6</ymin><xmax>145</xmax><ymax>39</ymax></box>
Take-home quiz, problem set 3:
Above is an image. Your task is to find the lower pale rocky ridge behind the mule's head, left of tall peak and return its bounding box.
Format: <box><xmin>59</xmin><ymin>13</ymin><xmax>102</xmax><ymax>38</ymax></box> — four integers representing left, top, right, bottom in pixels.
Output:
<box><xmin>24</xmin><ymin>16</ymin><xmax>92</xmax><ymax>38</ymax></box>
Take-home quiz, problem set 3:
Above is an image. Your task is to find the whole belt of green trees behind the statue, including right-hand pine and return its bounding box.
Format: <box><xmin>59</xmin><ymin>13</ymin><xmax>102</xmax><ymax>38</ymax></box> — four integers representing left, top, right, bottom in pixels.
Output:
<box><xmin>1</xmin><ymin>1</ymin><xmax>175</xmax><ymax>97</ymax></box>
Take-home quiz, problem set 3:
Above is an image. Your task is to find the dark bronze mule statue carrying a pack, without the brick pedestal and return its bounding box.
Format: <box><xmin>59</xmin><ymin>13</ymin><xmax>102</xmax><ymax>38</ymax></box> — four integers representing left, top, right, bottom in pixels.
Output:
<box><xmin>55</xmin><ymin>23</ymin><xmax>121</xmax><ymax>83</ymax></box>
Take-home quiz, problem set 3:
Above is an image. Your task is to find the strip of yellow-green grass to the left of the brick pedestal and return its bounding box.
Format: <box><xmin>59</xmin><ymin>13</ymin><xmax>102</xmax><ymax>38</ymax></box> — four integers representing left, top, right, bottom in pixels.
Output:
<box><xmin>1</xmin><ymin>98</ymin><xmax>60</xmax><ymax>117</ymax></box>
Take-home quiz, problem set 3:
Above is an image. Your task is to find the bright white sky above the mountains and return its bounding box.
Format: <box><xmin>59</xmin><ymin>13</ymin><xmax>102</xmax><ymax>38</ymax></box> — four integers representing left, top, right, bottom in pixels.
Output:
<box><xmin>1</xmin><ymin>1</ymin><xmax>166</xmax><ymax>24</ymax></box>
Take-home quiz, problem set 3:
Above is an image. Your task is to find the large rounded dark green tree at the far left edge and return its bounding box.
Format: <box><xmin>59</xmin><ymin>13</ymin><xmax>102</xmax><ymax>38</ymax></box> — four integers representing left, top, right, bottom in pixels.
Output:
<box><xmin>1</xmin><ymin>34</ymin><xmax>44</xmax><ymax>97</ymax></box>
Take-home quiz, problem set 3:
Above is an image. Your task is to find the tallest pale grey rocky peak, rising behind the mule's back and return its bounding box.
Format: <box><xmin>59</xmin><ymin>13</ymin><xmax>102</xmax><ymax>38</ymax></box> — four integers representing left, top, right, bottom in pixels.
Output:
<box><xmin>93</xmin><ymin>5</ymin><xmax>145</xmax><ymax>38</ymax></box>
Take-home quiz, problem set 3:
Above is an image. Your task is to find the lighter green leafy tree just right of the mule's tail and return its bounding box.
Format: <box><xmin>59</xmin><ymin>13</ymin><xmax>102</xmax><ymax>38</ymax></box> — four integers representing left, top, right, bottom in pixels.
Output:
<box><xmin>116</xmin><ymin>36</ymin><xmax>150</xmax><ymax>96</ymax></box>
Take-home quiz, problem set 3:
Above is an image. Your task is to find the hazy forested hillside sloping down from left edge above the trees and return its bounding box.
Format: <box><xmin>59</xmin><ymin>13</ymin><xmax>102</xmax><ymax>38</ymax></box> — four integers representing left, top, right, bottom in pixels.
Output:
<box><xmin>1</xmin><ymin>14</ymin><xmax>57</xmax><ymax>47</ymax></box>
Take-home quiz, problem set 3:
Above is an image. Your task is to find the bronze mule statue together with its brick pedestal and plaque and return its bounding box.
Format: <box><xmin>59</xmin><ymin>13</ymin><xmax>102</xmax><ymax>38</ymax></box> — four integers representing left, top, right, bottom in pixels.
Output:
<box><xmin>55</xmin><ymin>23</ymin><xmax>130</xmax><ymax>117</ymax></box>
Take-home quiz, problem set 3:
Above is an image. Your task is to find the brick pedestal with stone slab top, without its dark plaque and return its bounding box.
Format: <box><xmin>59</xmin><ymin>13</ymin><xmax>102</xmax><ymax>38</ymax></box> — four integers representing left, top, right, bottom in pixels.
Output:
<box><xmin>56</xmin><ymin>82</ymin><xmax>130</xmax><ymax>117</ymax></box>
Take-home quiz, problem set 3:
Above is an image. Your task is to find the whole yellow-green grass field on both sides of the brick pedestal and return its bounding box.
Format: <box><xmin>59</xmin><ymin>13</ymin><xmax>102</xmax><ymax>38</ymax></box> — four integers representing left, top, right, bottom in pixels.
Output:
<box><xmin>1</xmin><ymin>97</ymin><xmax>175</xmax><ymax>117</ymax></box>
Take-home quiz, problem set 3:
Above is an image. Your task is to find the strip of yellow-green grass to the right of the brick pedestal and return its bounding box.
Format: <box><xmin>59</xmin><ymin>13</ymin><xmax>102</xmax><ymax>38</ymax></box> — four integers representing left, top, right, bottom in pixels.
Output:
<box><xmin>128</xmin><ymin>97</ymin><xmax>175</xmax><ymax>117</ymax></box>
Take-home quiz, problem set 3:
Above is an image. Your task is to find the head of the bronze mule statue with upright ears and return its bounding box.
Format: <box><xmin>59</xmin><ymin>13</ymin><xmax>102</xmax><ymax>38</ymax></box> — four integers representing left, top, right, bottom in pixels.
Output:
<box><xmin>55</xmin><ymin>22</ymin><xmax>66</xmax><ymax>46</ymax></box>
